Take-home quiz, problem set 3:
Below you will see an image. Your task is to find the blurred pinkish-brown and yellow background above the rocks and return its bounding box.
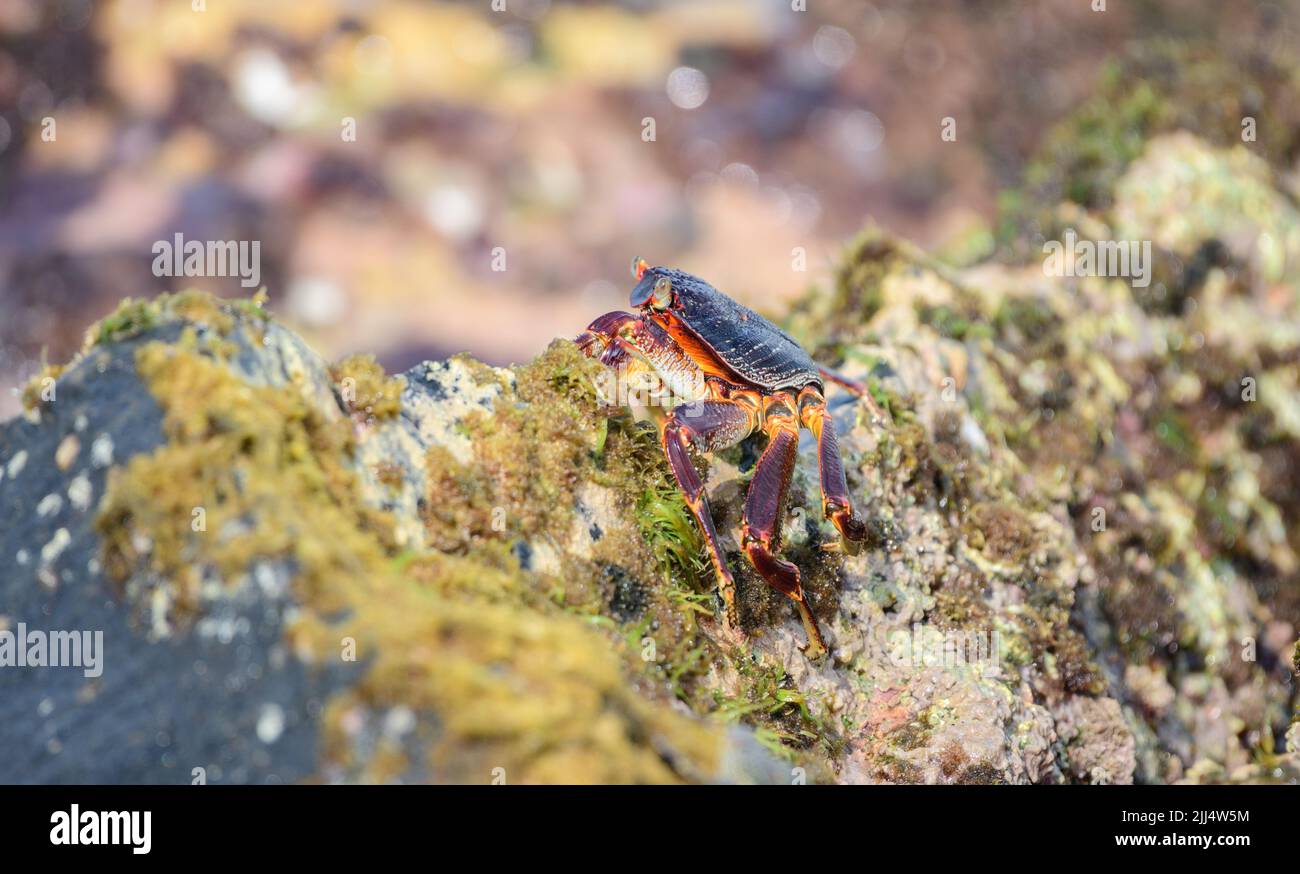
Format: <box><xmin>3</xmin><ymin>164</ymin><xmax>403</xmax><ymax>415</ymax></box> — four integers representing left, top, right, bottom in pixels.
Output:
<box><xmin>0</xmin><ymin>0</ymin><xmax>1297</xmax><ymax>416</ymax></box>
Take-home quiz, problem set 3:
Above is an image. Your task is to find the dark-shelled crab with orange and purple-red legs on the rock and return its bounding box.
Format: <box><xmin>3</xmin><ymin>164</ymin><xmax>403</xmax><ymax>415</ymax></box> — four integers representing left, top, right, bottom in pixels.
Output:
<box><xmin>575</xmin><ymin>259</ymin><xmax>883</xmax><ymax>658</ymax></box>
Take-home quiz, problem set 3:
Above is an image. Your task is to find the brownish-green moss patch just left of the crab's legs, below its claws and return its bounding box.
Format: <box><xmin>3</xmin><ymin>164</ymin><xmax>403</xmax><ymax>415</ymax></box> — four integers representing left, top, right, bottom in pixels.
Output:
<box><xmin>424</xmin><ymin>341</ymin><xmax>718</xmax><ymax>711</ymax></box>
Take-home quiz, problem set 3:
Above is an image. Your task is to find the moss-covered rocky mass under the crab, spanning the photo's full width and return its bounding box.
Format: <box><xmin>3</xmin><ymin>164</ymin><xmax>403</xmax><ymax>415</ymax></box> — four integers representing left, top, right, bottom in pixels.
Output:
<box><xmin>0</xmin><ymin>126</ymin><xmax>1300</xmax><ymax>783</ymax></box>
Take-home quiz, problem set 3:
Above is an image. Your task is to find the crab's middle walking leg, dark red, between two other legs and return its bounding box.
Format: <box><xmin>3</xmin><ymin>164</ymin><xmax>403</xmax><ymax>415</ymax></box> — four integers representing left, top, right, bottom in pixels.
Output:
<box><xmin>742</xmin><ymin>401</ymin><xmax>826</xmax><ymax>658</ymax></box>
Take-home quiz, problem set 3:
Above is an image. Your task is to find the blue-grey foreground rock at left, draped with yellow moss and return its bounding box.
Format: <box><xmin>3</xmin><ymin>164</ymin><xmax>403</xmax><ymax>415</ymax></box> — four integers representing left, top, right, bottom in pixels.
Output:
<box><xmin>0</xmin><ymin>294</ymin><xmax>789</xmax><ymax>783</ymax></box>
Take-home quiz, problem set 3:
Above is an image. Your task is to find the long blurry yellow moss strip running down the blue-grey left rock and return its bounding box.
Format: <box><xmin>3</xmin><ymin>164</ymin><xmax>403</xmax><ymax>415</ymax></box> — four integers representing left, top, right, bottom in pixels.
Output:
<box><xmin>96</xmin><ymin>300</ymin><xmax>722</xmax><ymax>783</ymax></box>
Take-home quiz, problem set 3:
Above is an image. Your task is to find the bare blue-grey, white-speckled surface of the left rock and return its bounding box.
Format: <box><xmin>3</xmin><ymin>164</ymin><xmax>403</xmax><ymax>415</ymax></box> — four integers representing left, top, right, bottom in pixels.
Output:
<box><xmin>0</xmin><ymin>317</ymin><xmax>348</xmax><ymax>783</ymax></box>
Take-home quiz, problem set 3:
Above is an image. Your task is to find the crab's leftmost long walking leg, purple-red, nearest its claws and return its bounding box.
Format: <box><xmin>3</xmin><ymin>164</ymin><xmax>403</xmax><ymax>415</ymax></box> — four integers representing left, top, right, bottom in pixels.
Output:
<box><xmin>660</xmin><ymin>399</ymin><xmax>758</xmax><ymax>633</ymax></box>
